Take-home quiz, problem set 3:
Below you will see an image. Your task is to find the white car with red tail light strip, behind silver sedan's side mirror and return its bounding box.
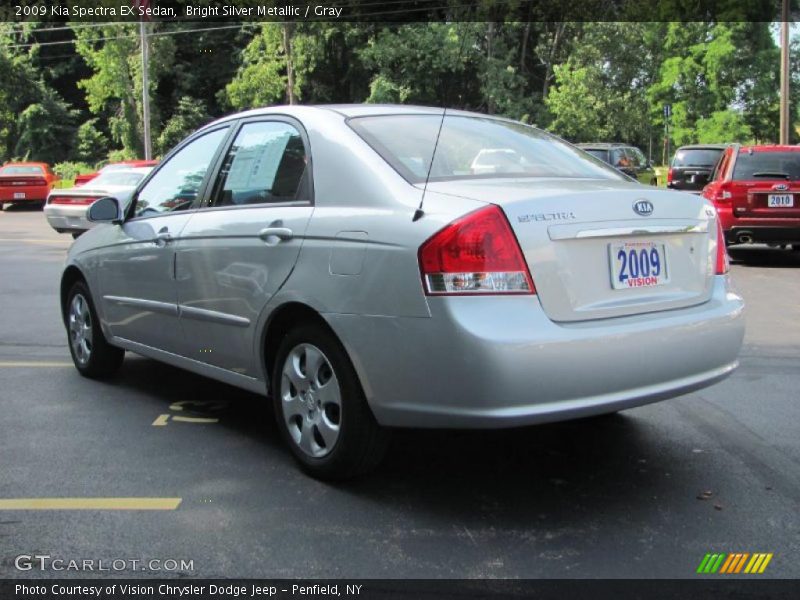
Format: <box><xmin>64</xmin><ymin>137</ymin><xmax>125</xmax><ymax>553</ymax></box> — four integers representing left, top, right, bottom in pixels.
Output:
<box><xmin>44</xmin><ymin>167</ymin><xmax>153</xmax><ymax>237</ymax></box>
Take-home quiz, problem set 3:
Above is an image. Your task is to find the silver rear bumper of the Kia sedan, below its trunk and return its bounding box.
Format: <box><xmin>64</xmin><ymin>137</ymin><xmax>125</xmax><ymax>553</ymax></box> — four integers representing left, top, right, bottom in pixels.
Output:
<box><xmin>324</xmin><ymin>277</ymin><xmax>744</xmax><ymax>428</ymax></box>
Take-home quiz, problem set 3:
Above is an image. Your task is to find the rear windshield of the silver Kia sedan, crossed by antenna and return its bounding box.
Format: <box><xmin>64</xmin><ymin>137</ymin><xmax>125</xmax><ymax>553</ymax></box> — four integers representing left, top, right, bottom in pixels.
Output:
<box><xmin>348</xmin><ymin>115</ymin><xmax>624</xmax><ymax>183</ymax></box>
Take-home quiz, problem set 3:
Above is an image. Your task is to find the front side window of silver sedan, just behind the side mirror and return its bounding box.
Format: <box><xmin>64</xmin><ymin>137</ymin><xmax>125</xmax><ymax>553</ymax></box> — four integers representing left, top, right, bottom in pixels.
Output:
<box><xmin>134</xmin><ymin>128</ymin><xmax>228</xmax><ymax>217</ymax></box>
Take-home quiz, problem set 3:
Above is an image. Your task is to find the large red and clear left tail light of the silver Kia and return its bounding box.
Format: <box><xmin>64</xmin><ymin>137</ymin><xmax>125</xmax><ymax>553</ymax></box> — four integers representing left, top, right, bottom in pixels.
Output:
<box><xmin>419</xmin><ymin>204</ymin><xmax>536</xmax><ymax>295</ymax></box>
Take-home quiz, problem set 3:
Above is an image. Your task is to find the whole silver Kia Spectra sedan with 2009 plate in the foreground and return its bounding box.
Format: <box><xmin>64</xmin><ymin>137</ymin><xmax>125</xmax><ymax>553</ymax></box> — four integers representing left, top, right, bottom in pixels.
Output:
<box><xmin>61</xmin><ymin>105</ymin><xmax>743</xmax><ymax>478</ymax></box>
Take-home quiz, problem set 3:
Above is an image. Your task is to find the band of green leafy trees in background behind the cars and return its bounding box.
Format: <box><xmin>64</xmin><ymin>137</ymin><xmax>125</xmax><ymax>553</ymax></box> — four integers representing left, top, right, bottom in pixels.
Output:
<box><xmin>0</xmin><ymin>19</ymin><xmax>800</xmax><ymax>163</ymax></box>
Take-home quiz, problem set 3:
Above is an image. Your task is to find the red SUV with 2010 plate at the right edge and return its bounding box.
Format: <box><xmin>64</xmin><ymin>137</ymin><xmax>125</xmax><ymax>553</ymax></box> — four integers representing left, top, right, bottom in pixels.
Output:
<box><xmin>703</xmin><ymin>144</ymin><xmax>800</xmax><ymax>250</ymax></box>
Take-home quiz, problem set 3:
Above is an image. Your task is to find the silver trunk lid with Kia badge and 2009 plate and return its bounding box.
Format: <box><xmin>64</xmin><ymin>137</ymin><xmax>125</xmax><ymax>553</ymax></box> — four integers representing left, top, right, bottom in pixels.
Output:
<box><xmin>428</xmin><ymin>179</ymin><xmax>716</xmax><ymax>322</ymax></box>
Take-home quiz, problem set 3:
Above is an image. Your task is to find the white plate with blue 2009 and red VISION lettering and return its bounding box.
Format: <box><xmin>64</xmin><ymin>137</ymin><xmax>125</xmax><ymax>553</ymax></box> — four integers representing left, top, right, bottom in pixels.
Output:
<box><xmin>608</xmin><ymin>242</ymin><xmax>669</xmax><ymax>290</ymax></box>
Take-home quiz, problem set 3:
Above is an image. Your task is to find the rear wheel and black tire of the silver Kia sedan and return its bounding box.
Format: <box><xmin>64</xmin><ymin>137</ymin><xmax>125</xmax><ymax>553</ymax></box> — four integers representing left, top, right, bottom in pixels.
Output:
<box><xmin>271</xmin><ymin>324</ymin><xmax>389</xmax><ymax>480</ymax></box>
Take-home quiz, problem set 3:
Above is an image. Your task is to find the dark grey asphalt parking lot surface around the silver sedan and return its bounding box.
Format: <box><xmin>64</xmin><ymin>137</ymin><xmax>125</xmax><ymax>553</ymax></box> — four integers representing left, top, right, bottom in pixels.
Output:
<box><xmin>0</xmin><ymin>207</ymin><xmax>800</xmax><ymax>578</ymax></box>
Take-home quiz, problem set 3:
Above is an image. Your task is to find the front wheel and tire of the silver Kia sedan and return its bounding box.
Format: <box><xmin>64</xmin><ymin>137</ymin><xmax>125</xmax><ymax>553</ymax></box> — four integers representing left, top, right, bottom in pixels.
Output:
<box><xmin>64</xmin><ymin>281</ymin><xmax>125</xmax><ymax>379</ymax></box>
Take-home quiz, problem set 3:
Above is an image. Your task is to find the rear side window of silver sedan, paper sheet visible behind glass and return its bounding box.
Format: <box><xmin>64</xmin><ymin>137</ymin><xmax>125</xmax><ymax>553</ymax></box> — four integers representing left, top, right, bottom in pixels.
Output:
<box><xmin>211</xmin><ymin>121</ymin><xmax>311</xmax><ymax>206</ymax></box>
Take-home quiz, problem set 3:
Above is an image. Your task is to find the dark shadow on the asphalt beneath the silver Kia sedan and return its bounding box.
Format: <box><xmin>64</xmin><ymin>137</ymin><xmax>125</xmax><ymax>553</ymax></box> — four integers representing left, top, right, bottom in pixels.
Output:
<box><xmin>109</xmin><ymin>358</ymin><xmax>683</xmax><ymax>527</ymax></box>
